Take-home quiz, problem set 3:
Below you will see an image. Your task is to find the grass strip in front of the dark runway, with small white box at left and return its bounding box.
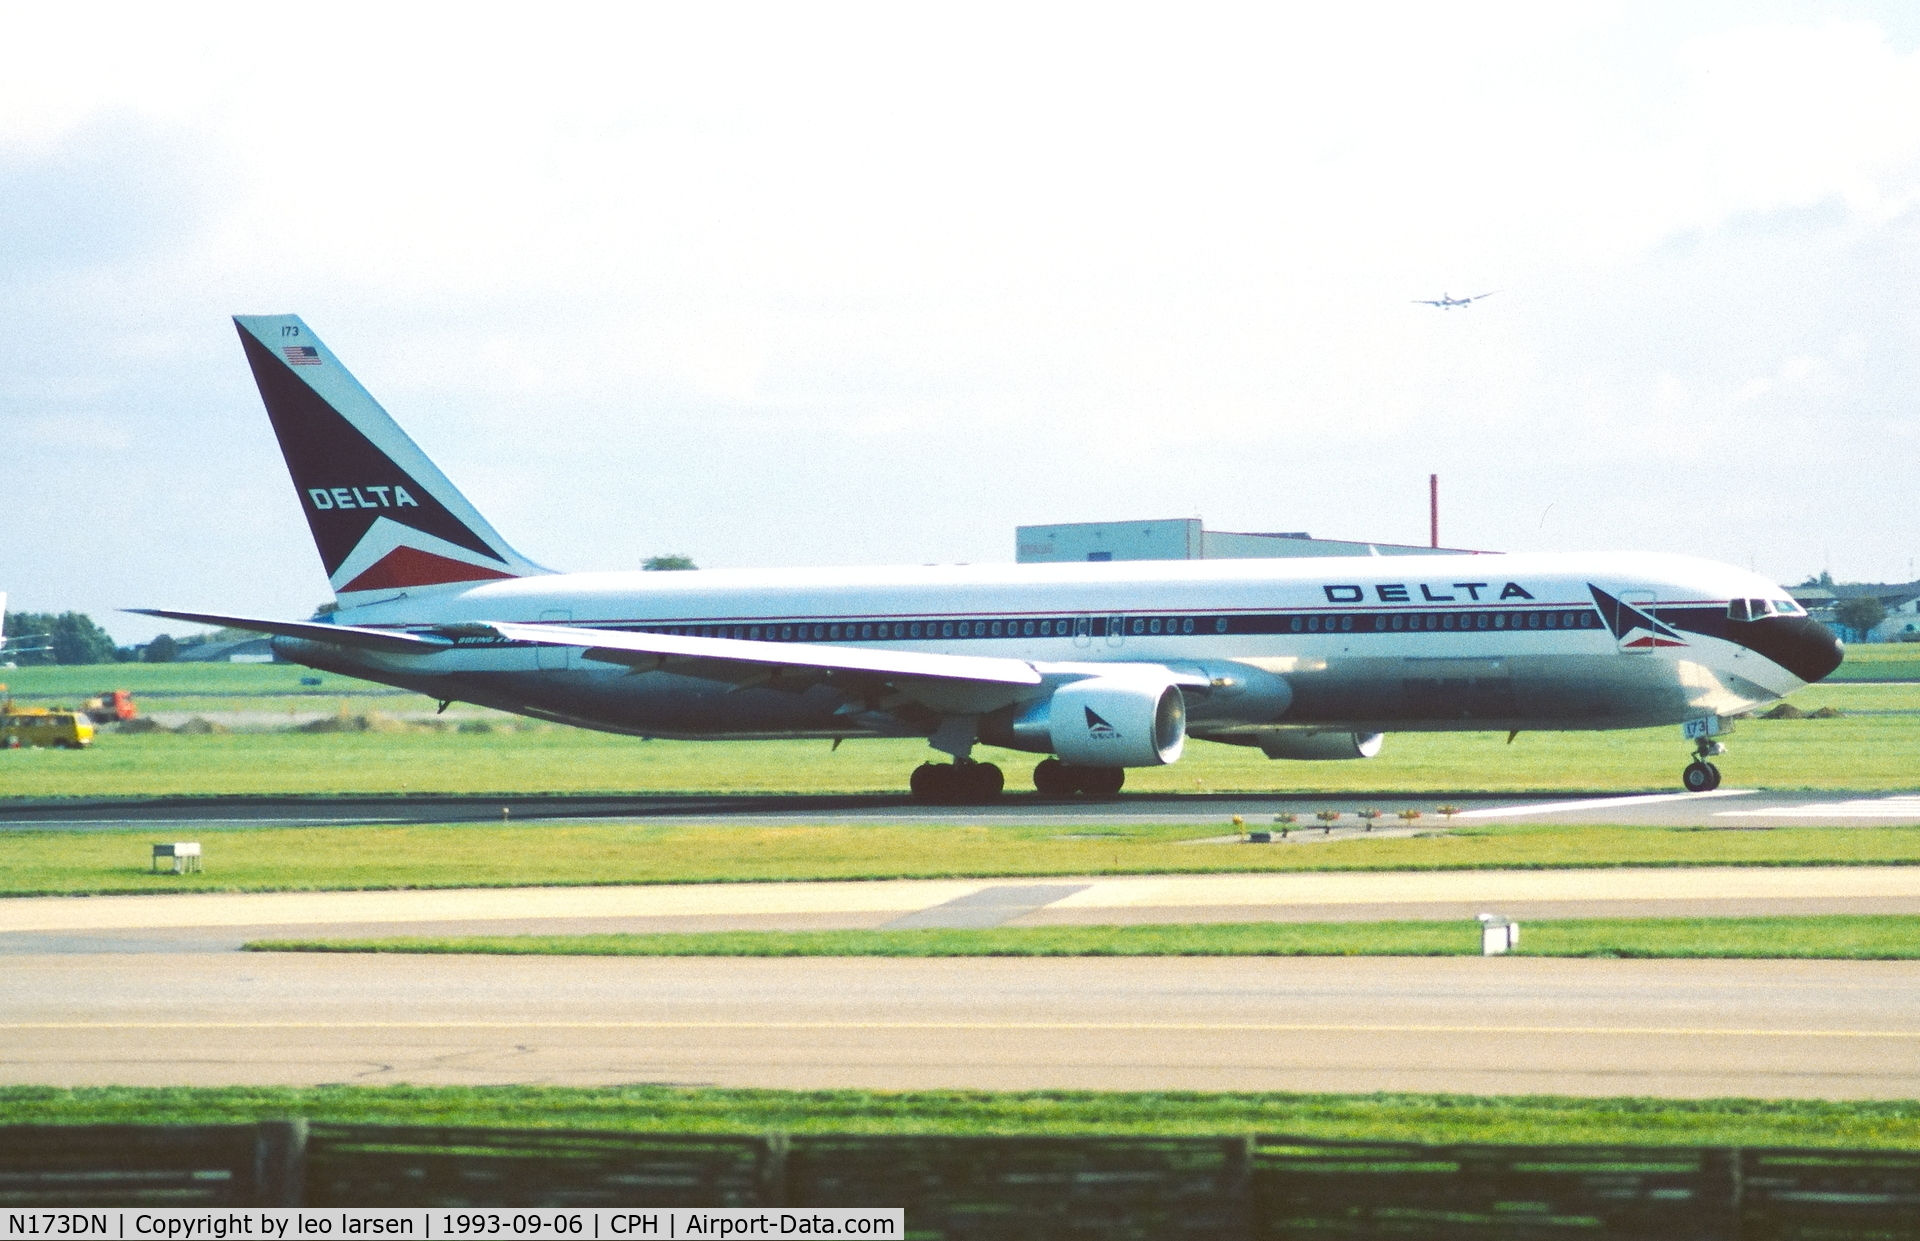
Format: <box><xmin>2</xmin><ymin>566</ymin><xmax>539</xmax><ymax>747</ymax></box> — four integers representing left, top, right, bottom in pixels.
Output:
<box><xmin>0</xmin><ymin>822</ymin><xmax>1920</xmax><ymax>895</ymax></box>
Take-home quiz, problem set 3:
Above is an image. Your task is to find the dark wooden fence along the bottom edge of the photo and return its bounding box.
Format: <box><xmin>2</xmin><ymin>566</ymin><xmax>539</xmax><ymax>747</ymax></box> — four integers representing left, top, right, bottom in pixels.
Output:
<box><xmin>0</xmin><ymin>1120</ymin><xmax>1920</xmax><ymax>1241</ymax></box>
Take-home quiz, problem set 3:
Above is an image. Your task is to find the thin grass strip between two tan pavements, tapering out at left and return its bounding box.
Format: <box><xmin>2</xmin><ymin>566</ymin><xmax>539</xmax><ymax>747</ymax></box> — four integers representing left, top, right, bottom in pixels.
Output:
<box><xmin>248</xmin><ymin>916</ymin><xmax>1920</xmax><ymax>961</ymax></box>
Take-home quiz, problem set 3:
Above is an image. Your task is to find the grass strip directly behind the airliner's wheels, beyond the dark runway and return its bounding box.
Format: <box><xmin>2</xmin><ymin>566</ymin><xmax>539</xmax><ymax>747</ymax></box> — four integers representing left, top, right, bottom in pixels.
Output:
<box><xmin>0</xmin><ymin>686</ymin><xmax>1920</xmax><ymax>799</ymax></box>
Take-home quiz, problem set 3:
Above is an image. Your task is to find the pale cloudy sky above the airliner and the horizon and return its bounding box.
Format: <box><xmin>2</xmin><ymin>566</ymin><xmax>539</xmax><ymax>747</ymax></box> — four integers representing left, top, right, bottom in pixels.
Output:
<box><xmin>0</xmin><ymin>2</ymin><xmax>1920</xmax><ymax>642</ymax></box>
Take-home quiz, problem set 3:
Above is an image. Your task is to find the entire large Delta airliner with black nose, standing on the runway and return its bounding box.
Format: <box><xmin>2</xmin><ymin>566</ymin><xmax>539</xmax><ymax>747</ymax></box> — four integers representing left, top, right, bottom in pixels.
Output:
<box><xmin>142</xmin><ymin>315</ymin><xmax>1841</xmax><ymax>801</ymax></box>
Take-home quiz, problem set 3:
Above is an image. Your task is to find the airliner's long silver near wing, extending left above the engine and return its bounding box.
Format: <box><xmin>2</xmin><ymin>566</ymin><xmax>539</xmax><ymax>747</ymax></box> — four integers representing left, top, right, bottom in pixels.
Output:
<box><xmin>487</xmin><ymin>621</ymin><xmax>1043</xmax><ymax>686</ymax></box>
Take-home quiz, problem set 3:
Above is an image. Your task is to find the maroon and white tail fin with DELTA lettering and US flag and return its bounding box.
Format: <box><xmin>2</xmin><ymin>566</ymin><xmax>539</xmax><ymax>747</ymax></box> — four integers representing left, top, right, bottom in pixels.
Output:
<box><xmin>234</xmin><ymin>315</ymin><xmax>549</xmax><ymax>607</ymax></box>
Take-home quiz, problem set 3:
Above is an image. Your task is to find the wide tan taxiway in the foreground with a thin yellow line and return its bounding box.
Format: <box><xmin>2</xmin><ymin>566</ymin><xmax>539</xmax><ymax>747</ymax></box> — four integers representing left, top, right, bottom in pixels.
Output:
<box><xmin>0</xmin><ymin>955</ymin><xmax>1920</xmax><ymax>1099</ymax></box>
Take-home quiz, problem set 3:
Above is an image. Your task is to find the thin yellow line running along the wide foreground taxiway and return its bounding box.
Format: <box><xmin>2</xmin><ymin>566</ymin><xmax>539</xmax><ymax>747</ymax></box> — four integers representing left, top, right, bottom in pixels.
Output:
<box><xmin>0</xmin><ymin>1022</ymin><xmax>1920</xmax><ymax>1041</ymax></box>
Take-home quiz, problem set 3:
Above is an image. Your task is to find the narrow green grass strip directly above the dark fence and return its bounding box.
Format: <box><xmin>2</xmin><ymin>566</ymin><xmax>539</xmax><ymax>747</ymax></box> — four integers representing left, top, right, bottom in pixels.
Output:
<box><xmin>0</xmin><ymin>1085</ymin><xmax>1920</xmax><ymax>1151</ymax></box>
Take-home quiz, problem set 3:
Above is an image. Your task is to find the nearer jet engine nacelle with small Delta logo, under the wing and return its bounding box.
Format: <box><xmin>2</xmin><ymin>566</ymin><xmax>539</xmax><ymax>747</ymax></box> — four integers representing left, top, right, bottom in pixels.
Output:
<box><xmin>979</xmin><ymin>676</ymin><xmax>1187</xmax><ymax>767</ymax></box>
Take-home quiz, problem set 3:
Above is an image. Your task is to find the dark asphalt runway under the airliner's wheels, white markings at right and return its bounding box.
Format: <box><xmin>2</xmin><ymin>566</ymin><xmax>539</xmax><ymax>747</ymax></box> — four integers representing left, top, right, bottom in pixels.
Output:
<box><xmin>0</xmin><ymin>788</ymin><xmax>1920</xmax><ymax>832</ymax></box>
